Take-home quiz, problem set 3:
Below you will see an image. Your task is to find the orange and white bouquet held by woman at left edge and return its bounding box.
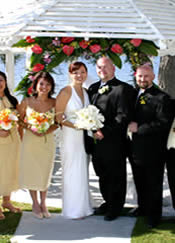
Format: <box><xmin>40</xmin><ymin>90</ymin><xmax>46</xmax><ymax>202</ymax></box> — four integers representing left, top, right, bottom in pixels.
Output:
<box><xmin>0</xmin><ymin>108</ymin><xmax>18</xmax><ymax>130</ymax></box>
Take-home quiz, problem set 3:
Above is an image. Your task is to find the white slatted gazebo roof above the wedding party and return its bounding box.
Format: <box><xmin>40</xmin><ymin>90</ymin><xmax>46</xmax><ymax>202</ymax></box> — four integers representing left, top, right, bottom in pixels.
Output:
<box><xmin>0</xmin><ymin>0</ymin><xmax>175</xmax><ymax>54</ymax></box>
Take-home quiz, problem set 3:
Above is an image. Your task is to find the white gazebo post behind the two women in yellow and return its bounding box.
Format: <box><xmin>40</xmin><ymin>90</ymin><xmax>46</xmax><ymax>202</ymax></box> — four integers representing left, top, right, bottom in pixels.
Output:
<box><xmin>5</xmin><ymin>50</ymin><xmax>15</xmax><ymax>93</ymax></box>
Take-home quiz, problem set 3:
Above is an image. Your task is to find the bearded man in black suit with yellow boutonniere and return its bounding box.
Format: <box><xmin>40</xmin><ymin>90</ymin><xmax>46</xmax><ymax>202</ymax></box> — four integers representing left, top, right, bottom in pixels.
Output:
<box><xmin>128</xmin><ymin>64</ymin><xmax>172</xmax><ymax>228</ymax></box>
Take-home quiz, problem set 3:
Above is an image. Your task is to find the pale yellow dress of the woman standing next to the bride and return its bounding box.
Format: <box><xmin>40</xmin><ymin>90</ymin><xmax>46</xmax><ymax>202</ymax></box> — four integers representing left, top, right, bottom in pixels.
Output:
<box><xmin>19</xmin><ymin>106</ymin><xmax>55</xmax><ymax>191</ymax></box>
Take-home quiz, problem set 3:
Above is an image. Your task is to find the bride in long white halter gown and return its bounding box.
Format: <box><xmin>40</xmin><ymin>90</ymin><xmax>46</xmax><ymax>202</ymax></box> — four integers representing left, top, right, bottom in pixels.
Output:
<box><xmin>56</xmin><ymin>62</ymin><xmax>93</xmax><ymax>219</ymax></box>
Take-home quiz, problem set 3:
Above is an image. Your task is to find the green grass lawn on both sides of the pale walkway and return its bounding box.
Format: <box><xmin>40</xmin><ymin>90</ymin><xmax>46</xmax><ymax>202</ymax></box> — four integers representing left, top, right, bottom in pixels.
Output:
<box><xmin>0</xmin><ymin>203</ymin><xmax>175</xmax><ymax>243</ymax></box>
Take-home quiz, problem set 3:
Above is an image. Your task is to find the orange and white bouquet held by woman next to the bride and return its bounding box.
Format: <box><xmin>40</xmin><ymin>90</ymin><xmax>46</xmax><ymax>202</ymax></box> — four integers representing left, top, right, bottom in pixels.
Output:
<box><xmin>25</xmin><ymin>108</ymin><xmax>54</xmax><ymax>133</ymax></box>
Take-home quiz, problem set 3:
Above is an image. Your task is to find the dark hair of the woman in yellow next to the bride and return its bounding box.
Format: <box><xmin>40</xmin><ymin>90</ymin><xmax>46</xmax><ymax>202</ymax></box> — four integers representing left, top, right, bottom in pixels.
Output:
<box><xmin>33</xmin><ymin>72</ymin><xmax>55</xmax><ymax>98</ymax></box>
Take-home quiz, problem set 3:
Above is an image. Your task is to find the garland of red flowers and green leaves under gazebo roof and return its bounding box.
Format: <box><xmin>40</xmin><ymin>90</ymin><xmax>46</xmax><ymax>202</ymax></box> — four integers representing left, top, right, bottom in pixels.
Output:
<box><xmin>13</xmin><ymin>36</ymin><xmax>158</xmax><ymax>97</ymax></box>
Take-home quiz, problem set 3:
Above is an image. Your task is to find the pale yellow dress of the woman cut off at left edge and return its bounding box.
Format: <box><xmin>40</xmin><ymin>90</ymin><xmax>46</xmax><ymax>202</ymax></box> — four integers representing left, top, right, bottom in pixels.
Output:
<box><xmin>0</xmin><ymin>96</ymin><xmax>20</xmax><ymax>196</ymax></box>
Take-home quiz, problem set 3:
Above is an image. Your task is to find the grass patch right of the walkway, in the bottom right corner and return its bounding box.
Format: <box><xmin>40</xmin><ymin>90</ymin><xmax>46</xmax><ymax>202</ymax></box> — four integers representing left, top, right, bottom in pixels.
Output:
<box><xmin>131</xmin><ymin>217</ymin><xmax>175</xmax><ymax>243</ymax></box>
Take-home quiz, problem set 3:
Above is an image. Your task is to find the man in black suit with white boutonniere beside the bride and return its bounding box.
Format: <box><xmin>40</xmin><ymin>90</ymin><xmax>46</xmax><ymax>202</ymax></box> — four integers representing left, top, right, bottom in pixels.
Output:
<box><xmin>88</xmin><ymin>57</ymin><xmax>134</xmax><ymax>221</ymax></box>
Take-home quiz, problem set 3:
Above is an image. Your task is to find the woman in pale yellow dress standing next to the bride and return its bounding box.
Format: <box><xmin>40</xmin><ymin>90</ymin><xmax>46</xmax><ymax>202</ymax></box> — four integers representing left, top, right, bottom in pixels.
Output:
<box><xmin>19</xmin><ymin>72</ymin><xmax>58</xmax><ymax>219</ymax></box>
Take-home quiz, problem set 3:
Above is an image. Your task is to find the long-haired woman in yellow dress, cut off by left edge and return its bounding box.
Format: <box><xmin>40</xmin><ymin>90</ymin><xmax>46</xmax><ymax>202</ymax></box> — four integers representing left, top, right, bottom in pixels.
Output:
<box><xmin>0</xmin><ymin>71</ymin><xmax>21</xmax><ymax>220</ymax></box>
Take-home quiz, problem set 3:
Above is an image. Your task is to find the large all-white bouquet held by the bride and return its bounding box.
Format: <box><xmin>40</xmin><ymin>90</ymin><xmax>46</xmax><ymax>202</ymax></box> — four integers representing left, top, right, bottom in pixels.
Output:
<box><xmin>74</xmin><ymin>105</ymin><xmax>105</xmax><ymax>131</ymax></box>
